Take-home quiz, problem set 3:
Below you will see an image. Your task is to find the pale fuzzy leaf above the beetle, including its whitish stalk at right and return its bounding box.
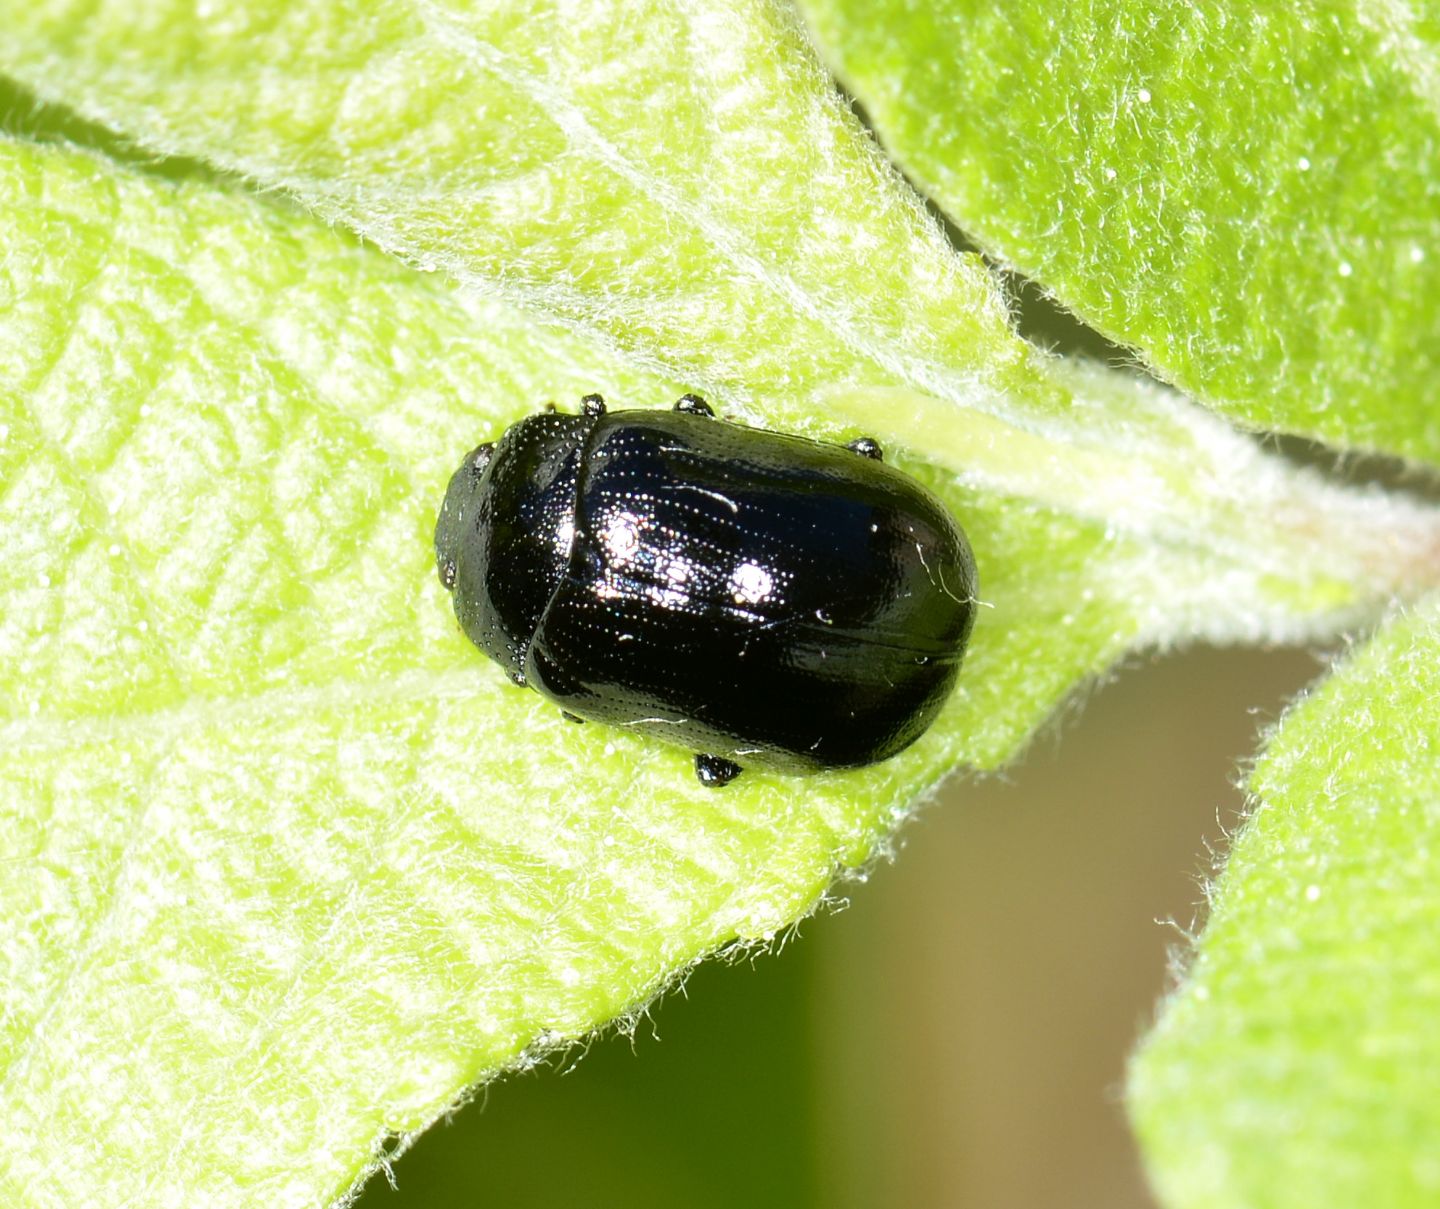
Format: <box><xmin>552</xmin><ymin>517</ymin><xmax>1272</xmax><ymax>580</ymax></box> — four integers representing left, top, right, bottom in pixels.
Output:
<box><xmin>0</xmin><ymin>0</ymin><xmax>1433</xmax><ymax>641</ymax></box>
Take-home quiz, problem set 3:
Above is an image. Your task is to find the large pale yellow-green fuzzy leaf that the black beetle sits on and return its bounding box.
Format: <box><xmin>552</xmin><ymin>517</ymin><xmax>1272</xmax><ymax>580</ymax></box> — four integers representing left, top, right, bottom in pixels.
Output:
<box><xmin>0</xmin><ymin>142</ymin><xmax>1369</xmax><ymax>1206</ymax></box>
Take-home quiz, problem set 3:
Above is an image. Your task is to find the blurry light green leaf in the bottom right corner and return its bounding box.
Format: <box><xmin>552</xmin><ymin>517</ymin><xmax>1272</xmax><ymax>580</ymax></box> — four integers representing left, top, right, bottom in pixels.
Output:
<box><xmin>1129</xmin><ymin>599</ymin><xmax>1440</xmax><ymax>1209</ymax></box>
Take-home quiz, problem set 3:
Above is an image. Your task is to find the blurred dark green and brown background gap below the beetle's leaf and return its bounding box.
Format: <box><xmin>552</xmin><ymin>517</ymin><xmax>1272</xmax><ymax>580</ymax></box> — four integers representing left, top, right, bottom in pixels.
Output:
<box><xmin>360</xmin><ymin>649</ymin><xmax>1319</xmax><ymax>1209</ymax></box>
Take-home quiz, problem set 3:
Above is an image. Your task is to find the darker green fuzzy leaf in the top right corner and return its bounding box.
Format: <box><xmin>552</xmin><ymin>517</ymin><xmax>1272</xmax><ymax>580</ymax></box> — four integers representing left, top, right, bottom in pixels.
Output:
<box><xmin>801</xmin><ymin>0</ymin><xmax>1440</xmax><ymax>462</ymax></box>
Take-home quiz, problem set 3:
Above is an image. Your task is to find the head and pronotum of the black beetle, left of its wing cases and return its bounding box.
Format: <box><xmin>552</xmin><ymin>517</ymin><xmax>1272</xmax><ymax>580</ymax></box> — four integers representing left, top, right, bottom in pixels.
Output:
<box><xmin>435</xmin><ymin>413</ymin><xmax>598</xmax><ymax>684</ymax></box>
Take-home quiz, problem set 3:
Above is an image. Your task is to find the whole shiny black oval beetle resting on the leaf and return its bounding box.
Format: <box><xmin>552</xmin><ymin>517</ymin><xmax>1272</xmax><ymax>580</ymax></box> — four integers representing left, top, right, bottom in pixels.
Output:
<box><xmin>435</xmin><ymin>394</ymin><xmax>975</xmax><ymax>786</ymax></box>
